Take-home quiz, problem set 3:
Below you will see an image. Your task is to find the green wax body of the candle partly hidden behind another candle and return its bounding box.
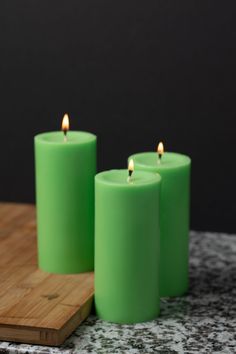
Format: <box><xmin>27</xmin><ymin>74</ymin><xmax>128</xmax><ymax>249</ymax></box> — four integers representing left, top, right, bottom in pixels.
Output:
<box><xmin>130</xmin><ymin>152</ymin><xmax>191</xmax><ymax>296</ymax></box>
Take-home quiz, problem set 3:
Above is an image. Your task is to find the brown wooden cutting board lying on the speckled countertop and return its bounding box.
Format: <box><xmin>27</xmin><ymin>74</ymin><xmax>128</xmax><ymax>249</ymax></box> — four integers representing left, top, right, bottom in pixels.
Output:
<box><xmin>0</xmin><ymin>203</ymin><xmax>94</xmax><ymax>345</ymax></box>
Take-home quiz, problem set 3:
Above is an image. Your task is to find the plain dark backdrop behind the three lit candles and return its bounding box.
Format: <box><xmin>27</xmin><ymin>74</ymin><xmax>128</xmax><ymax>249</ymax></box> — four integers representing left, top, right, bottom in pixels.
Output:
<box><xmin>0</xmin><ymin>0</ymin><xmax>236</xmax><ymax>232</ymax></box>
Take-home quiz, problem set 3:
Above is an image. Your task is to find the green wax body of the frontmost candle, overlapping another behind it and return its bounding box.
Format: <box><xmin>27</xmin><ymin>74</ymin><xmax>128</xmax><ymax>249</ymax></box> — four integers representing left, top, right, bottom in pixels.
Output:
<box><xmin>95</xmin><ymin>170</ymin><xmax>161</xmax><ymax>323</ymax></box>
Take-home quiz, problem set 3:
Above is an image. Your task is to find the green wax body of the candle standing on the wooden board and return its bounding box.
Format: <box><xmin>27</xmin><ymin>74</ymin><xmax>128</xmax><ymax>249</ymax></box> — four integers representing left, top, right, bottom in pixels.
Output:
<box><xmin>35</xmin><ymin>131</ymin><xmax>96</xmax><ymax>274</ymax></box>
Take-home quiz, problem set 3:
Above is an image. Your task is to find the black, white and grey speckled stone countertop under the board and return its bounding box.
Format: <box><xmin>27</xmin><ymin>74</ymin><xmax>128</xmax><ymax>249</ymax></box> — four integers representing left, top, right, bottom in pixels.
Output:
<box><xmin>0</xmin><ymin>232</ymin><xmax>236</xmax><ymax>354</ymax></box>
